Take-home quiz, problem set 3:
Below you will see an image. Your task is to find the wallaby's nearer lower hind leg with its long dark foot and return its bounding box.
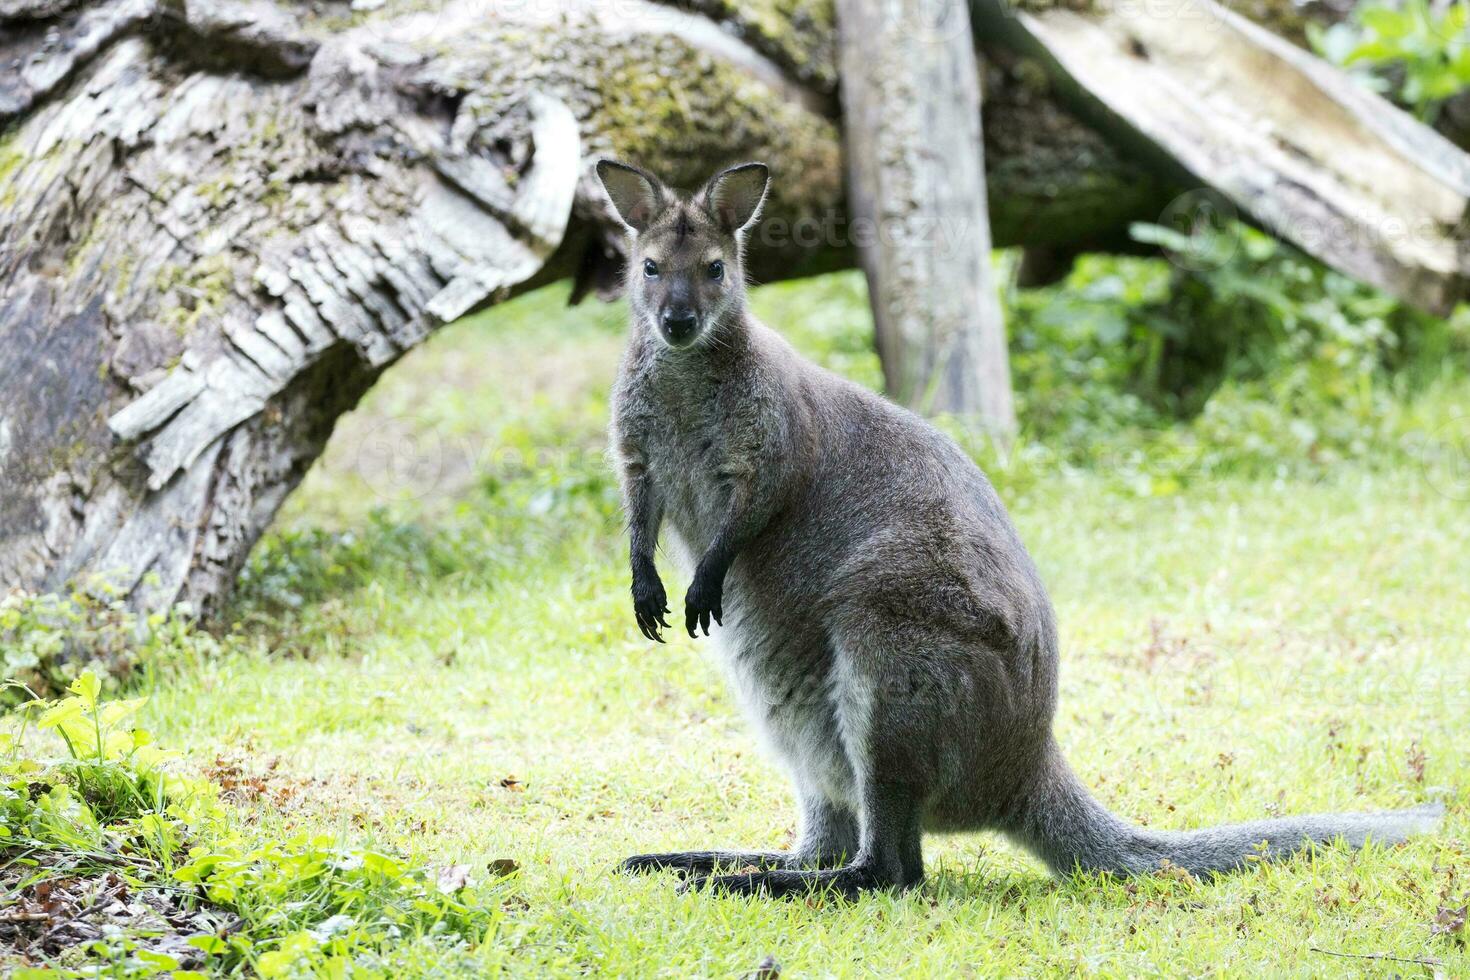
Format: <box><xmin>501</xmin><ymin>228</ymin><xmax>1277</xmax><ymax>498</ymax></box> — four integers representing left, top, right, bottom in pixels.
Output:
<box><xmin>685</xmin><ymin>783</ymin><xmax>923</xmax><ymax>898</ymax></box>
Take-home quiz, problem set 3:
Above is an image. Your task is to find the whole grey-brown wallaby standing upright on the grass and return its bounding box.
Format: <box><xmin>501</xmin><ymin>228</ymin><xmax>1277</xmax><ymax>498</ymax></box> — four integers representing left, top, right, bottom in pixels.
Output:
<box><xmin>597</xmin><ymin>160</ymin><xmax>1441</xmax><ymax>896</ymax></box>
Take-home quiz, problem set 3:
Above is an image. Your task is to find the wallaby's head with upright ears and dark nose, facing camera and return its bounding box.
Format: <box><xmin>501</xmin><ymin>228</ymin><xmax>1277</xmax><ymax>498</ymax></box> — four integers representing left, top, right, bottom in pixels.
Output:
<box><xmin>597</xmin><ymin>160</ymin><xmax>770</xmax><ymax>347</ymax></box>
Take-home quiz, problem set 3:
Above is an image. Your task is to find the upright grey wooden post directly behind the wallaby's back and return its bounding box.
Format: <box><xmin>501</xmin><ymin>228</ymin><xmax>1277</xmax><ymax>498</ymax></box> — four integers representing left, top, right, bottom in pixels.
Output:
<box><xmin>836</xmin><ymin>0</ymin><xmax>1016</xmax><ymax>439</ymax></box>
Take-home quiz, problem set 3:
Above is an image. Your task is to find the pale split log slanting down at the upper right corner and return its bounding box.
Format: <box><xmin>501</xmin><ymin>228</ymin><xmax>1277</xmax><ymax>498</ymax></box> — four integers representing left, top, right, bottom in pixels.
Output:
<box><xmin>976</xmin><ymin>0</ymin><xmax>1470</xmax><ymax>313</ymax></box>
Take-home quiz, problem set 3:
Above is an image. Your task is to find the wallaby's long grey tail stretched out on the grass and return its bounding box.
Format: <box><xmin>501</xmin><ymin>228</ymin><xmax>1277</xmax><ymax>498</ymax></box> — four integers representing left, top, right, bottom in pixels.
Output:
<box><xmin>1010</xmin><ymin>746</ymin><xmax>1444</xmax><ymax>874</ymax></box>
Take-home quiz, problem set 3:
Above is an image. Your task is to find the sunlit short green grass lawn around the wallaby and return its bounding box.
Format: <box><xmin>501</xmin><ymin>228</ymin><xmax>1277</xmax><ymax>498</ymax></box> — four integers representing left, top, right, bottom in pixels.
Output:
<box><xmin>5</xmin><ymin>276</ymin><xmax>1470</xmax><ymax>977</ymax></box>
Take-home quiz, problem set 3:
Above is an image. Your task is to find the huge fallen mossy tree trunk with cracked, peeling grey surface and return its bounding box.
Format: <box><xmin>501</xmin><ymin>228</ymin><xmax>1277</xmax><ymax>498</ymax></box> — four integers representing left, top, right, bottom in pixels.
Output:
<box><xmin>0</xmin><ymin>0</ymin><xmax>1464</xmax><ymax>608</ymax></box>
